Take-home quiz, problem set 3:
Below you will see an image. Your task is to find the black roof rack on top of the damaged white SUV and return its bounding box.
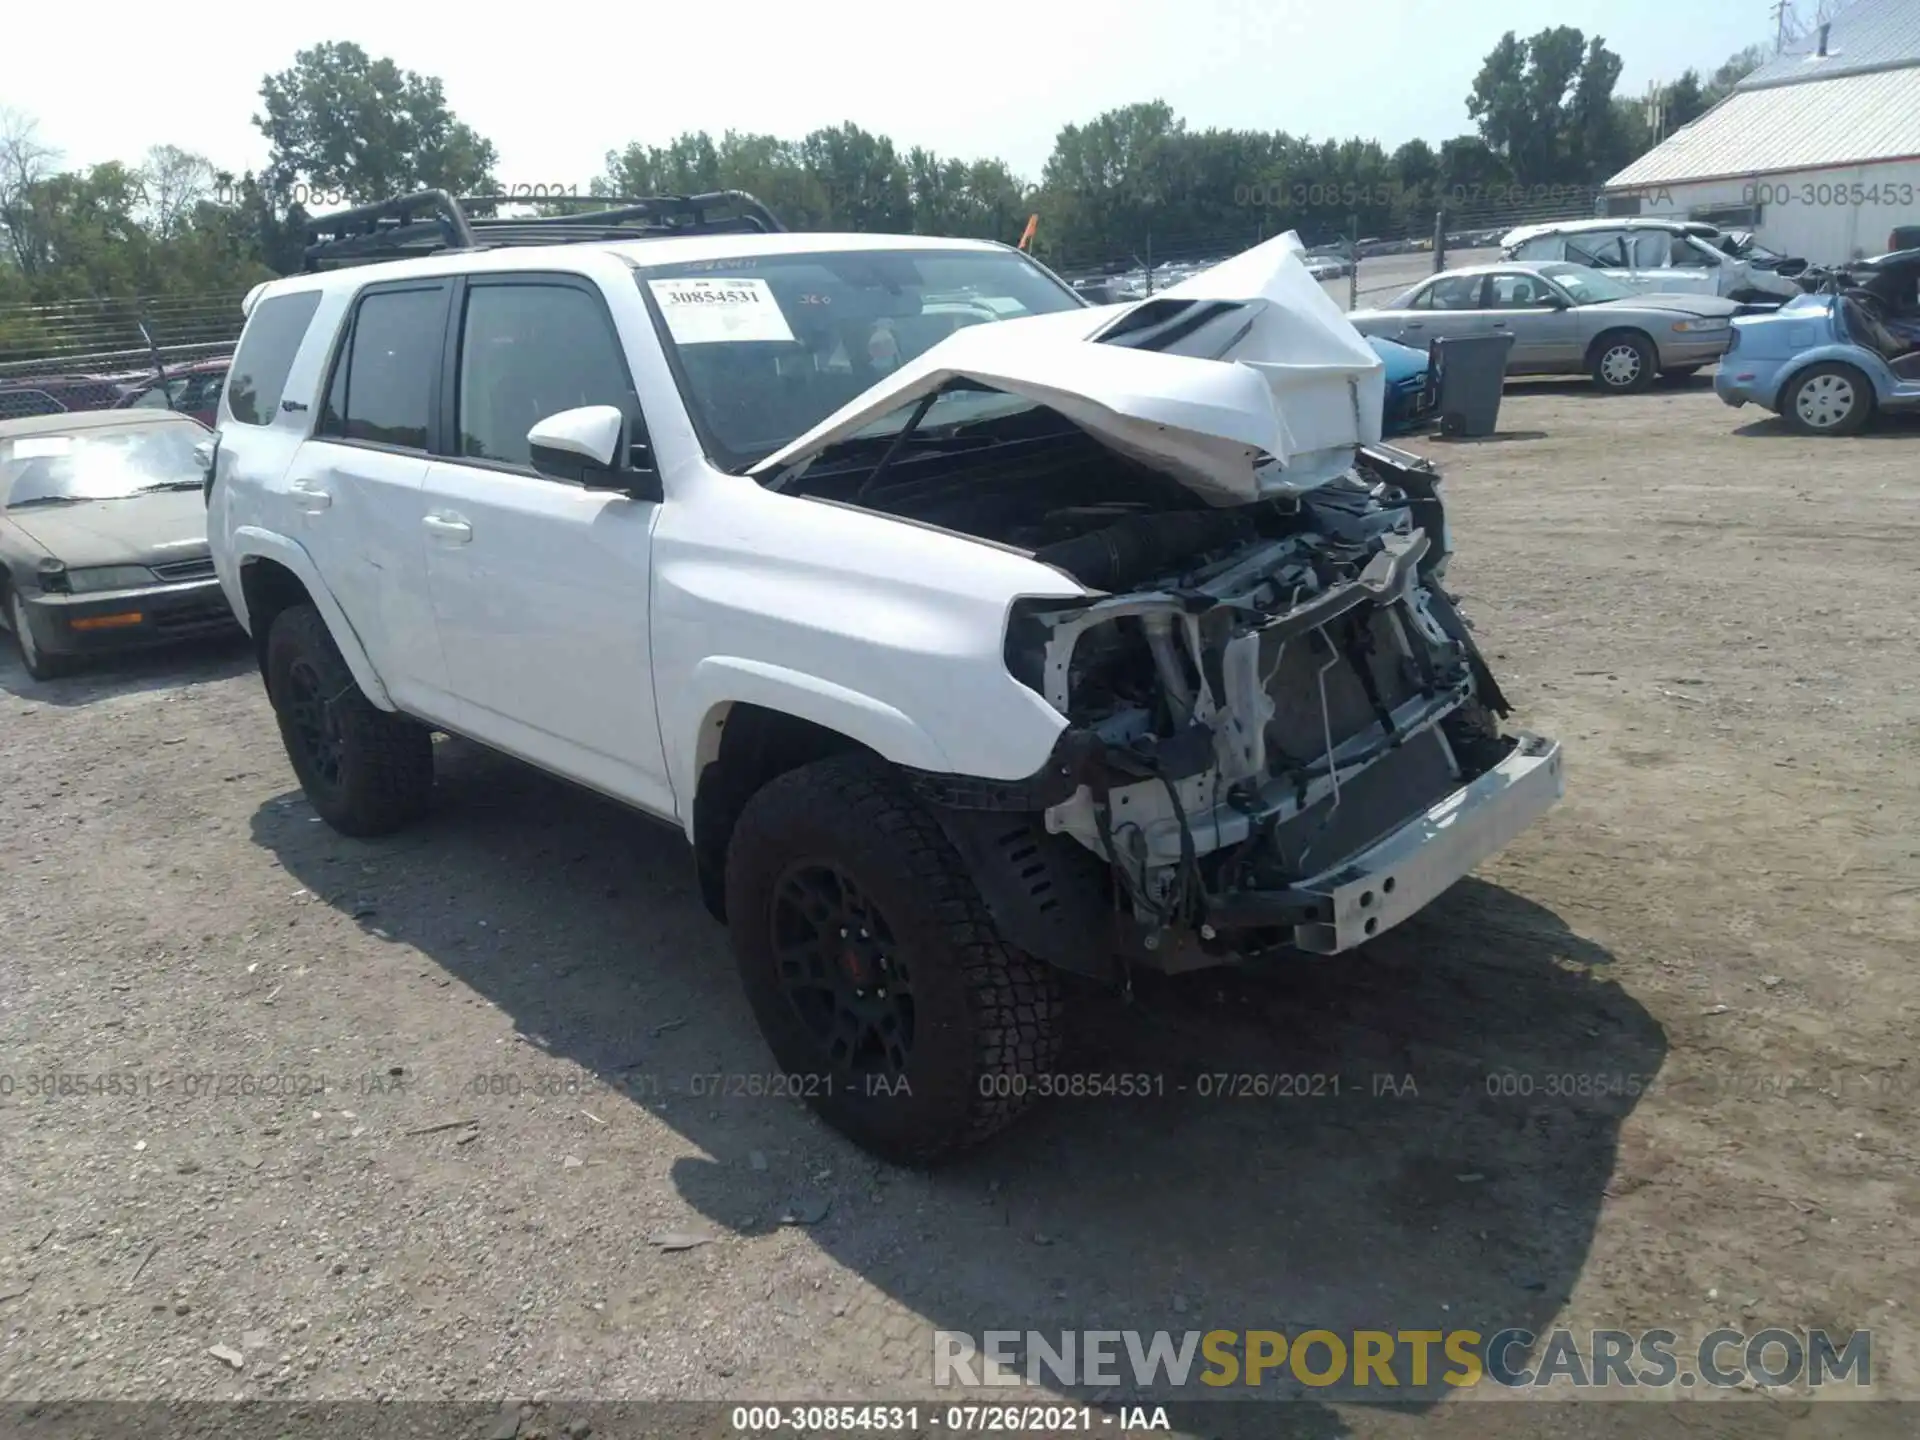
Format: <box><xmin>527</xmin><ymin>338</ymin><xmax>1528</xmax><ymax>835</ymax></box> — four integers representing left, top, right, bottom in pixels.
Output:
<box><xmin>305</xmin><ymin>190</ymin><xmax>787</xmax><ymax>271</ymax></box>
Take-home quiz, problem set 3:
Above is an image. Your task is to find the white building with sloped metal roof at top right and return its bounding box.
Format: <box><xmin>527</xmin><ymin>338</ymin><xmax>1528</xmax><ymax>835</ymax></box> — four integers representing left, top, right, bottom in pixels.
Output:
<box><xmin>1605</xmin><ymin>0</ymin><xmax>1920</xmax><ymax>265</ymax></box>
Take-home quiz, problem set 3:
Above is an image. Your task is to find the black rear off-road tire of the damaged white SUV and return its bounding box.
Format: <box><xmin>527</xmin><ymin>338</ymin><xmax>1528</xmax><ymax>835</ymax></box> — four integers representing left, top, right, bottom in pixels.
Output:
<box><xmin>267</xmin><ymin>605</ymin><xmax>434</xmax><ymax>837</ymax></box>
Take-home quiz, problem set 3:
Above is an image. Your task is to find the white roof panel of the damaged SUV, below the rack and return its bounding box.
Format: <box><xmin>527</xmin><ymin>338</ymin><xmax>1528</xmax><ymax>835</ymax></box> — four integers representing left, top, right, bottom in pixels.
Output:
<box><xmin>266</xmin><ymin>230</ymin><xmax>1012</xmax><ymax>309</ymax></box>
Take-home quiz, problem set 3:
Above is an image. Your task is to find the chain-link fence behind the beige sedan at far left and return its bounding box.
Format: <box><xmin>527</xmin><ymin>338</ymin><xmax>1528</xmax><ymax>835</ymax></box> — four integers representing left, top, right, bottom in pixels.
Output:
<box><xmin>0</xmin><ymin>294</ymin><xmax>242</xmax><ymax>420</ymax></box>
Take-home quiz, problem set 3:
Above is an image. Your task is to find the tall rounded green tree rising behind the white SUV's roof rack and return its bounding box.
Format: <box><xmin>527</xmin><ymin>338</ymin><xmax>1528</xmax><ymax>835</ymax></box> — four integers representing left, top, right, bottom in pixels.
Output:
<box><xmin>253</xmin><ymin>42</ymin><xmax>497</xmax><ymax>204</ymax></box>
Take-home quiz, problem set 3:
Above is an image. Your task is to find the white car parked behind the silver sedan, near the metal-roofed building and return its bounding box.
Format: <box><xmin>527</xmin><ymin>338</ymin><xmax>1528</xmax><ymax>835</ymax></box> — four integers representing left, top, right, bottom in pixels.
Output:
<box><xmin>1500</xmin><ymin>219</ymin><xmax>1801</xmax><ymax>303</ymax></box>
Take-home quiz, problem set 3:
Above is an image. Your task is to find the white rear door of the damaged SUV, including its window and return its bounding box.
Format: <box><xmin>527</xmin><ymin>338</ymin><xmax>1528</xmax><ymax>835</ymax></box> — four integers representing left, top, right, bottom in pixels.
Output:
<box><xmin>280</xmin><ymin>278</ymin><xmax>453</xmax><ymax>706</ymax></box>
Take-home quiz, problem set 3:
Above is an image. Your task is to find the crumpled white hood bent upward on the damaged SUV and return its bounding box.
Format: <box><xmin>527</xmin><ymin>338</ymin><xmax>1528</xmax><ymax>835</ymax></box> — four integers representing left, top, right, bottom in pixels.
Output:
<box><xmin>753</xmin><ymin>232</ymin><xmax>1386</xmax><ymax>505</ymax></box>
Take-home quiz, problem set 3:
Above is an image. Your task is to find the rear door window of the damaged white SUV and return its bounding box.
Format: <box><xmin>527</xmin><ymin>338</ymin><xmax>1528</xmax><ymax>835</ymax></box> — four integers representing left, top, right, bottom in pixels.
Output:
<box><xmin>317</xmin><ymin>286</ymin><xmax>447</xmax><ymax>449</ymax></box>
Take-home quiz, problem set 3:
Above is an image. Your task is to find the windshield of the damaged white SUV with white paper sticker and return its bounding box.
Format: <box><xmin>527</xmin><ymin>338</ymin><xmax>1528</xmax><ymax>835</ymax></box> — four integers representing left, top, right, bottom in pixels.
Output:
<box><xmin>639</xmin><ymin>250</ymin><xmax>1083</xmax><ymax>470</ymax></box>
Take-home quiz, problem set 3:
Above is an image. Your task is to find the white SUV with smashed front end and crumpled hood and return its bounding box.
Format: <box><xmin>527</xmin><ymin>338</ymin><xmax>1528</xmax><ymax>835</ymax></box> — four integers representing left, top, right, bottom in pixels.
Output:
<box><xmin>207</xmin><ymin>192</ymin><xmax>1561</xmax><ymax>1160</ymax></box>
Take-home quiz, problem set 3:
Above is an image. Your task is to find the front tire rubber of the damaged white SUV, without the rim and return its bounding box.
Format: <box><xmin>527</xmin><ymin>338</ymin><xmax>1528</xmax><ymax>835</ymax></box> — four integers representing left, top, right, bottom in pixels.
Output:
<box><xmin>726</xmin><ymin>755</ymin><xmax>1062</xmax><ymax>1165</ymax></box>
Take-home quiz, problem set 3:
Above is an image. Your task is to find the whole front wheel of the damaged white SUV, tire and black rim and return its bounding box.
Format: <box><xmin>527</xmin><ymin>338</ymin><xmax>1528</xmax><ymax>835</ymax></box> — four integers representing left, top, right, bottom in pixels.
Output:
<box><xmin>726</xmin><ymin>755</ymin><xmax>1060</xmax><ymax>1165</ymax></box>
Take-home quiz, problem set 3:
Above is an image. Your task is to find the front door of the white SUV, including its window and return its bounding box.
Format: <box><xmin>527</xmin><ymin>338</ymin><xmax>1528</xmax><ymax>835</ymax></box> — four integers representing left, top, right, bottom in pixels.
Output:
<box><xmin>422</xmin><ymin>275</ymin><xmax>674</xmax><ymax>814</ymax></box>
